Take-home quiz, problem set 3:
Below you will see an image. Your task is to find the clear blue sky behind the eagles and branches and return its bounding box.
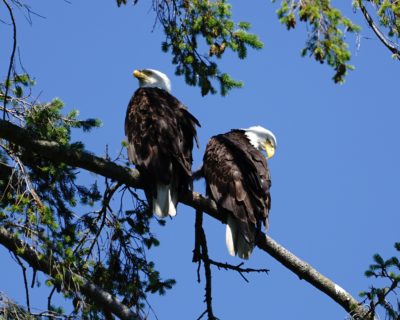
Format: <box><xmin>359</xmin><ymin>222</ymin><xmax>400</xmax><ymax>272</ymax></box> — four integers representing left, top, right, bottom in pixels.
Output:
<box><xmin>0</xmin><ymin>0</ymin><xmax>400</xmax><ymax>320</ymax></box>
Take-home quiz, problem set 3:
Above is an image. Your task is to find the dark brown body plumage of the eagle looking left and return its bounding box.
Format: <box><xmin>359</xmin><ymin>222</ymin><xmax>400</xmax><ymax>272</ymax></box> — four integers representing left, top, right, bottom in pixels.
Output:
<box><xmin>125</xmin><ymin>88</ymin><xmax>200</xmax><ymax>192</ymax></box>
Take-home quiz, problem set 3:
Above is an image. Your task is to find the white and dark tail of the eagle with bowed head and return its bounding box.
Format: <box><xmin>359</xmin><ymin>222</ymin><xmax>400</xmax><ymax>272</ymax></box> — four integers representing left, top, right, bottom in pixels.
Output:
<box><xmin>226</xmin><ymin>216</ymin><xmax>253</xmax><ymax>259</ymax></box>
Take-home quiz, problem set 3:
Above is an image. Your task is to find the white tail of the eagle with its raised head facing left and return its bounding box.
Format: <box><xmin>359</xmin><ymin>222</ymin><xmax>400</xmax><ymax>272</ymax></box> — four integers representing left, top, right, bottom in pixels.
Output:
<box><xmin>153</xmin><ymin>183</ymin><xmax>178</xmax><ymax>218</ymax></box>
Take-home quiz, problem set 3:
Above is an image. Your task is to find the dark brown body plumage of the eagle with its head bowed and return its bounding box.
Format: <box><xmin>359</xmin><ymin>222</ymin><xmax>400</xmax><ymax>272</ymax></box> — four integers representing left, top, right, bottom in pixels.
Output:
<box><xmin>203</xmin><ymin>130</ymin><xmax>271</xmax><ymax>243</ymax></box>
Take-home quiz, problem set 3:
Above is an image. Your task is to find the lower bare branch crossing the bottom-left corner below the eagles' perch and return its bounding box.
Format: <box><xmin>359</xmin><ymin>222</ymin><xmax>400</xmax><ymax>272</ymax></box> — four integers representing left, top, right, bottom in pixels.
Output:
<box><xmin>0</xmin><ymin>227</ymin><xmax>142</xmax><ymax>320</ymax></box>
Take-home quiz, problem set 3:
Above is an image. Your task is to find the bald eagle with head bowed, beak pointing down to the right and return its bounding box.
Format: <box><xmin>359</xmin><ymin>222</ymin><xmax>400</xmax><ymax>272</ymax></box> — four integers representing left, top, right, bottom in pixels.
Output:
<box><xmin>197</xmin><ymin>126</ymin><xmax>276</xmax><ymax>259</ymax></box>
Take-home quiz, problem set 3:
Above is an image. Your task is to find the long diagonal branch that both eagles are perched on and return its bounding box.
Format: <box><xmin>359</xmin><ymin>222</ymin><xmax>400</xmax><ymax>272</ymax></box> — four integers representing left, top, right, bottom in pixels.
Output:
<box><xmin>0</xmin><ymin>120</ymin><xmax>369</xmax><ymax>320</ymax></box>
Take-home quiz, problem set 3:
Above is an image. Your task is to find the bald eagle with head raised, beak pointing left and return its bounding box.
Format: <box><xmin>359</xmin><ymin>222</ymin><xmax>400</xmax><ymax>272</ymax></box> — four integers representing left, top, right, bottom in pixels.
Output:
<box><xmin>125</xmin><ymin>69</ymin><xmax>200</xmax><ymax>218</ymax></box>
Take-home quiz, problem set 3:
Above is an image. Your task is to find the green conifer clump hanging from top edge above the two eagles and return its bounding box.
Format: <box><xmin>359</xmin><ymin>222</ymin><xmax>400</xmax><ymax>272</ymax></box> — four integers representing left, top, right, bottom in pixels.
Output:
<box><xmin>117</xmin><ymin>0</ymin><xmax>263</xmax><ymax>95</ymax></box>
